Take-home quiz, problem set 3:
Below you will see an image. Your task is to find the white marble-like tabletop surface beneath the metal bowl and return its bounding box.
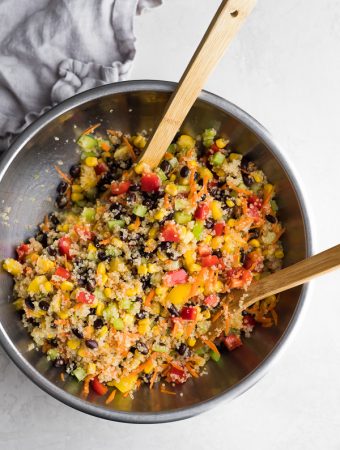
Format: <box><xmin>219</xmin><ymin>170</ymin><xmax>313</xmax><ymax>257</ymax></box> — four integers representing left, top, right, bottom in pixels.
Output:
<box><xmin>0</xmin><ymin>0</ymin><xmax>340</xmax><ymax>450</ymax></box>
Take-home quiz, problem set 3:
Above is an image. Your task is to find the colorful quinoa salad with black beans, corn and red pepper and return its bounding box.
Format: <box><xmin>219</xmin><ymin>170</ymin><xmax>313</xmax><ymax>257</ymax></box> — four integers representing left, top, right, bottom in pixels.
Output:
<box><xmin>3</xmin><ymin>125</ymin><xmax>284</xmax><ymax>403</ymax></box>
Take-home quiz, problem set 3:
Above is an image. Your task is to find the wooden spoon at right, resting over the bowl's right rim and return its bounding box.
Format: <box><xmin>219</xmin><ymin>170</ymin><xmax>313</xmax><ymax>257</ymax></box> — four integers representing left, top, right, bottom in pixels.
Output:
<box><xmin>200</xmin><ymin>245</ymin><xmax>340</xmax><ymax>346</ymax></box>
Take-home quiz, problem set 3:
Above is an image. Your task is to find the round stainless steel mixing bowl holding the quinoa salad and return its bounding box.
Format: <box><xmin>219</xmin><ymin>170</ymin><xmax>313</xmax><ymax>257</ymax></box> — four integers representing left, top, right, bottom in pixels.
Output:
<box><xmin>0</xmin><ymin>81</ymin><xmax>311</xmax><ymax>423</ymax></box>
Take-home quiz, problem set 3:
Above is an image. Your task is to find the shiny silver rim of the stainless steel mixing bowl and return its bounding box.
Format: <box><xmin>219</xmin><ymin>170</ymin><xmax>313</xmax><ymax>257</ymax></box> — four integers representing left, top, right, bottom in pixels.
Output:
<box><xmin>0</xmin><ymin>80</ymin><xmax>312</xmax><ymax>423</ymax></box>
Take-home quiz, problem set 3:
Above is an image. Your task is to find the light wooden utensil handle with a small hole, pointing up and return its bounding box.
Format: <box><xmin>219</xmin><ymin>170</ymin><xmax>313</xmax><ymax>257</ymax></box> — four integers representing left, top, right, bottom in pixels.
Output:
<box><xmin>140</xmin><ymin>0</ymin><xmax>256</xmax><ymax>168</ymax></box>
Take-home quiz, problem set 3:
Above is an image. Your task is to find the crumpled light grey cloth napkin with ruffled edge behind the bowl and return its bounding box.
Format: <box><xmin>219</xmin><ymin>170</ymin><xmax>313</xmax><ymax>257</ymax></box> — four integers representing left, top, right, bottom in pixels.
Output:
<box><xmin>0</xmin><ymin>0</ymin><xmax>162</xmax><ymax>152</ymax></box>
